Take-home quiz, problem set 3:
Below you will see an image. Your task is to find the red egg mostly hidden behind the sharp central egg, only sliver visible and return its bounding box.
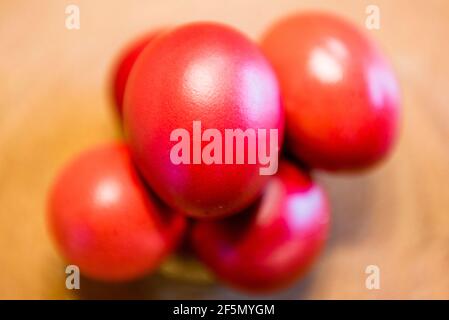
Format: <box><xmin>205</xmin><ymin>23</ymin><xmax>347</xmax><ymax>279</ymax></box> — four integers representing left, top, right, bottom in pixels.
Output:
<box><xmin>112</xmin><ymin>30</ymin><xmax>162</xmax><ymax>116</ymax></box>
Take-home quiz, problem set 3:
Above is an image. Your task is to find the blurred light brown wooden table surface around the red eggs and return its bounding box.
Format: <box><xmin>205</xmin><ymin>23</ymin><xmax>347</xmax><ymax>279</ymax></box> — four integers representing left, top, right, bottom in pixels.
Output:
<box><xmin>0</xmin><ymin>0</ymin><xmax>449</xmax><ymax>299</ymax></box>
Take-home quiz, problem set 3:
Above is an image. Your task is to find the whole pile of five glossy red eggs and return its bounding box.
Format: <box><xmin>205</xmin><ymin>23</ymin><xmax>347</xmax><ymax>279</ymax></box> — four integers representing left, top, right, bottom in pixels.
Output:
<box><xmin>48</xmin><ymin>12</ymin><xmax>400</xmax><ymax>291</ymax></box>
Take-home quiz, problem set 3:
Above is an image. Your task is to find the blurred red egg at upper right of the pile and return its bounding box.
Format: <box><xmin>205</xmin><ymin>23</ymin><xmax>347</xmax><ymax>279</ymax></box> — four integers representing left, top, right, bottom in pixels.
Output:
<box><xmin>261</xmin><ymin>12</ymin><xmax>400</xmax><ymax>170</ymax></box>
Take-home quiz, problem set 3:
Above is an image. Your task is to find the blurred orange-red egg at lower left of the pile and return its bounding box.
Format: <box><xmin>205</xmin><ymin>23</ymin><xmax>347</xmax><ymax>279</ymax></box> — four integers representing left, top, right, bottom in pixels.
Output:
<box><xmin>48</xmin><ymin>143</ymin><xmax>186</xmax><ymax>281</ymax></box>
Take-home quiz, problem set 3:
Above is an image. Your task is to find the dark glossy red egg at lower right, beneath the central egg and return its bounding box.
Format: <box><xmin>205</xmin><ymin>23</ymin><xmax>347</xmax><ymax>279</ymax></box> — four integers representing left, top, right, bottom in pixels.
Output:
<box><xmin>191</xmin><ymin>162</ymin><xmax>329</xmax><ymax>292</ymax></box>
